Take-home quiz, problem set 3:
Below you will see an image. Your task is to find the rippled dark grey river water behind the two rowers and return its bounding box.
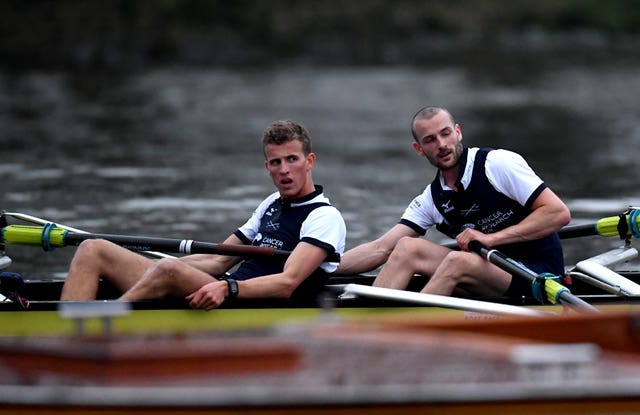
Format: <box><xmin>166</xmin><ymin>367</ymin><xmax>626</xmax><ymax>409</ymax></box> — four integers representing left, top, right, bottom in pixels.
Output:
<box><xmin>0</xmin><ymin>56</ymin><xmax>640</xmax><ymax>275</ymax></box>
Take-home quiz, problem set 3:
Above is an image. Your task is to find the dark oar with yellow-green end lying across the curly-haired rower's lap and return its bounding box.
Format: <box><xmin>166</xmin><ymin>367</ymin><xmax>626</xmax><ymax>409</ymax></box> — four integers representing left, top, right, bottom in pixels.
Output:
<box><xmin>0</xmin><ymin>224</ymin><xmax>340</xmax><ymax>261</ymax></box>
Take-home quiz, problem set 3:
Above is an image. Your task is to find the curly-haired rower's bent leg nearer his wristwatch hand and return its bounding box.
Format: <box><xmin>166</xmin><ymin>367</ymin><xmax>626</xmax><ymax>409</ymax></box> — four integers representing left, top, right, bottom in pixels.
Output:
<box><xmin>120</xmin><ymin>259</ymin><xmax>215</xmax><ymax>301</ymax></box>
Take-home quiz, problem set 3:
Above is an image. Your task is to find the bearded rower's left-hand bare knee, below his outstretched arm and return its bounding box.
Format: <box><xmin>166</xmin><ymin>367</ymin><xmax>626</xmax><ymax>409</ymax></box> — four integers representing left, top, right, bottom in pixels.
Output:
<box><xmin>373</xmin><ymin>237</ymin><xmax>451</xmax><ymax>290</ymax></box>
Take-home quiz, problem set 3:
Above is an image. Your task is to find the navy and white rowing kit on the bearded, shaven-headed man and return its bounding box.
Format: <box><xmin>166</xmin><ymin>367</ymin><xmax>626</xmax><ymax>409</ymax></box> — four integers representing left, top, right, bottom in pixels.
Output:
<box><xmin>400</xmin><ymin>148</ymin><xmax>564</xmax><ymax>275</ymax></box>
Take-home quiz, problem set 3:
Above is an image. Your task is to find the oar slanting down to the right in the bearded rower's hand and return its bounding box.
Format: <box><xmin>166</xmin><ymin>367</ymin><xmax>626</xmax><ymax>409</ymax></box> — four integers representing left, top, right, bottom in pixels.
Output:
<box><xmin>469</xmin><ymin>241</ymin><xmax>599</xmax><ymax>313</ymax></box>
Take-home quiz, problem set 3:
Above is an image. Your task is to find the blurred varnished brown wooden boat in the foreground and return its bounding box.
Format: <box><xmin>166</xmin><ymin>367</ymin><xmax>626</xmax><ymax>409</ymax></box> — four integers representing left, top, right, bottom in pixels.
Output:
<box><xmin>0</xmin><ymin>308</ymin><xmax>640</xmax><ymax>415</ymax></box>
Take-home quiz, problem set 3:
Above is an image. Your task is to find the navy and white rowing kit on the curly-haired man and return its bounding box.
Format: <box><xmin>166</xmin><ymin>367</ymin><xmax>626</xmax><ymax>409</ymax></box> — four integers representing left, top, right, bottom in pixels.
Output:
<box><xmin>232</xmin><ymin>186</ymin><xmax>346</xmax><ymax>300</ymax></box>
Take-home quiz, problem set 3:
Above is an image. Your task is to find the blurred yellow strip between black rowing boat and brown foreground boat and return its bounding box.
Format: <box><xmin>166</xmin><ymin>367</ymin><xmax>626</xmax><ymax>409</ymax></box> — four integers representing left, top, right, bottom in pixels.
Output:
<box><xmin>0</xmin><ymin>306</ymin><xmax>480</xmax><ymax>336</ymax></box>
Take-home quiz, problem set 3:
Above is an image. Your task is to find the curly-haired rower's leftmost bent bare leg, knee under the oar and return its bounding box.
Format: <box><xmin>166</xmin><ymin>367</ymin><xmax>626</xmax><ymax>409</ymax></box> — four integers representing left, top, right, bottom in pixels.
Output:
<box><xmin>60</xmin><ymin>239</ymin><xmax>153</xmax><ymax>301</ymax></box>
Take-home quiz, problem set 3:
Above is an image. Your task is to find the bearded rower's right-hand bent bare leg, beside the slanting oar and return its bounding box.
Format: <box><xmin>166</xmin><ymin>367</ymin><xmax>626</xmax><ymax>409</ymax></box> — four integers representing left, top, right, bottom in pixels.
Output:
<box><xmin>422</xmin><ymin>251</ymin><xmax>511</xmax><ymax>296</ymax></box>
